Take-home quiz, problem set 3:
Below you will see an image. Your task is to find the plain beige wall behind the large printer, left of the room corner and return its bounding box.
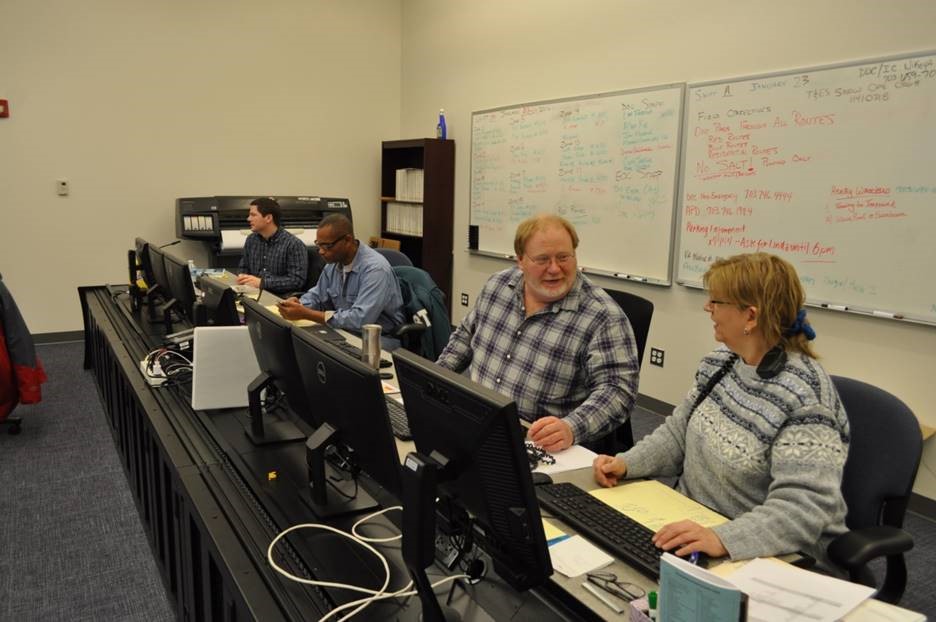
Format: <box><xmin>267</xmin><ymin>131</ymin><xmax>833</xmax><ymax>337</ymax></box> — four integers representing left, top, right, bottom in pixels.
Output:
<box><xmin>0</xmin><ymin>0</ymin><xmax>401</xmax><ymax>333</ymax></box>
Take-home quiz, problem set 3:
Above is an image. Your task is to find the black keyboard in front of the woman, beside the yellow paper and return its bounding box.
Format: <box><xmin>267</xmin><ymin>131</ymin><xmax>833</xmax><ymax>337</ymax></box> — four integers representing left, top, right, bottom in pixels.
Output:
<box><xmin>536</xmin><ymin>483</ymin><xmax>663</xmax><ymax>580</ymax></box>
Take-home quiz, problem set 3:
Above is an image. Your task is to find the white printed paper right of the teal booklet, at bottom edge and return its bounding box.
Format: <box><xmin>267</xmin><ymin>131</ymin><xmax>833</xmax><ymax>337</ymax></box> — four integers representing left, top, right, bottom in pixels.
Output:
<box><xmin>729</xmin><ymin>559</ymin><xmax>874</xmax><ymax>622</ymax></box>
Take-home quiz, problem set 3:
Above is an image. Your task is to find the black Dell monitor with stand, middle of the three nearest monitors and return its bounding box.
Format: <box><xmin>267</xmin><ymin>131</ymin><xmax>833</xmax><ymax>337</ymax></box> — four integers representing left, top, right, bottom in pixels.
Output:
<box><xmin>293</xmin><ymin>328</ymin><xmax>402</xmax><ymax>517</ymax></box>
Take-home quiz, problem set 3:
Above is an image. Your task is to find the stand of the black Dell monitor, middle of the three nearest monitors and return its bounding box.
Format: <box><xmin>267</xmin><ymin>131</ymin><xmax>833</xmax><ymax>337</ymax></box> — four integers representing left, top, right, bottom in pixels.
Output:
<box><xmin>302</xmin><ymin>423</ymin><xmax>378</xmax><ymax>518</ymax></box>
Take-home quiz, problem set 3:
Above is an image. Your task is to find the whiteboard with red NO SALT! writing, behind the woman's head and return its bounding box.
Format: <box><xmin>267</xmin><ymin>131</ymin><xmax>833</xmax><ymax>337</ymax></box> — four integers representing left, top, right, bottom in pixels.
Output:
<box><xmin>676</xmin><ymin>53</ymin><xmax>936</xmax><ymax>323</ymax></box>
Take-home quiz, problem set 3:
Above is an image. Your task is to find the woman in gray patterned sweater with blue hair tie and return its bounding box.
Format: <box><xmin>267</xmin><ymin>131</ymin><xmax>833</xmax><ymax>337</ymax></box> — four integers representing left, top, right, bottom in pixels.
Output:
<box><xmin>594</xmin><ymin>253</ymin><xmax>848</xmax><ymax>567</ymax></box>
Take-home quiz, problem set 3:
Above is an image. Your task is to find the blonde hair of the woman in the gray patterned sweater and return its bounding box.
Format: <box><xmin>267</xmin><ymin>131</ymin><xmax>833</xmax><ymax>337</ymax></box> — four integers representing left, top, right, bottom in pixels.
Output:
<box><xmin>702</xmin><ymin>253</ymin><xmax>816</xmax><ymax>358</ymax></box>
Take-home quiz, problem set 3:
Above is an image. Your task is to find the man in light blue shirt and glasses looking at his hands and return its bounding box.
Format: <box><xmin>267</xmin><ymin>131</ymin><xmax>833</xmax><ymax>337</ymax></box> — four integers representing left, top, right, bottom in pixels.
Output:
<box><xmin>279</xmin><ymin>214</ymin><xmax>405</xmax><ymax>342</ymax></box>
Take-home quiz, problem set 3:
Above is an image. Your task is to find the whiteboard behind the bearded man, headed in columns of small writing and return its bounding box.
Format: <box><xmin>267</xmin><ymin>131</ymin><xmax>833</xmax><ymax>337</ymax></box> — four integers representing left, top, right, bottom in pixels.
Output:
<box><xmin>469</xmin><ymin>84</ymin><xmax>685</xmax><ymax>285</ymax></box>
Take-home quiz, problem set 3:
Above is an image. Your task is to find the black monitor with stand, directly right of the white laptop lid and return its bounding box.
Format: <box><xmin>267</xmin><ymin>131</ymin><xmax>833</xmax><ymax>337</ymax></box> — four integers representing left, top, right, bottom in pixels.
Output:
<box><xmin>241</xmin><ymin>298</ymin><xmax>310</xmax><ymax>445</ymax></box>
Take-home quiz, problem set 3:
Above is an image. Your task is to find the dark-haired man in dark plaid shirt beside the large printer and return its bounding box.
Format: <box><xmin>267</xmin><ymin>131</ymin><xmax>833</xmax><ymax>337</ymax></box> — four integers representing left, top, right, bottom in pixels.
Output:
<box><xmin>237</xmin><ymin>197</ymin><xmax>309</xmax><ymax>294</ymax></box>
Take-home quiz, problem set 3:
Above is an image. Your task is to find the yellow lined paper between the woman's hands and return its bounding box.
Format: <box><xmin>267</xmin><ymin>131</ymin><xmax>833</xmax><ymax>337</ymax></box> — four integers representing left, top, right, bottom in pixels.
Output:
<box><xmin>590</xmin><ymin>480</ymin><xmax>728</xmax><ymax>531</ymax></box>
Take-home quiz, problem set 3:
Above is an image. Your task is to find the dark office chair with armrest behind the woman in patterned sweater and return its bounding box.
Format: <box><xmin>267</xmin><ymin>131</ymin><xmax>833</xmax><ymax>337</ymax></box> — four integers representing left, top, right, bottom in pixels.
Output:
<box><xmin>827</xmin><ymin>376</ymin><xmax>923</xmax><ymax>603</ymax></box>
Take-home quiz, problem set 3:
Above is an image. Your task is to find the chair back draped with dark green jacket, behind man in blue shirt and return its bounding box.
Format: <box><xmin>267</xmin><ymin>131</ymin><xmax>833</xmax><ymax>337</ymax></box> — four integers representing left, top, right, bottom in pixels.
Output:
<box><xmin>394</xmin><ymin>266</ymin><xmax>452</xmax><ymax>361</ymax></box>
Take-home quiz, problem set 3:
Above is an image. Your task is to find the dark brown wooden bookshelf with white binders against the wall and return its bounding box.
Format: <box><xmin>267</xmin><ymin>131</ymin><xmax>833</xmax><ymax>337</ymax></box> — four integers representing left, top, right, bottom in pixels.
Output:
<box><xmin>380</xmin><ymin>138</ymin><xmax>455</xmax><ymax>317</ymax></box>
